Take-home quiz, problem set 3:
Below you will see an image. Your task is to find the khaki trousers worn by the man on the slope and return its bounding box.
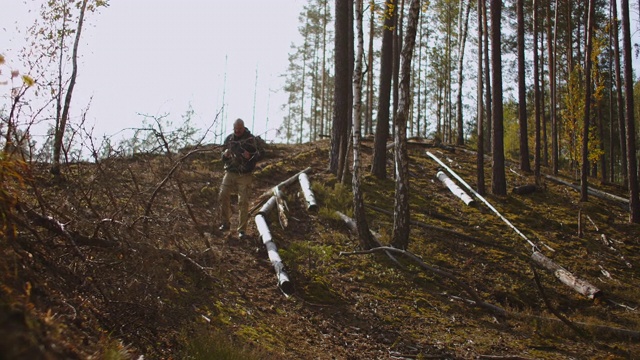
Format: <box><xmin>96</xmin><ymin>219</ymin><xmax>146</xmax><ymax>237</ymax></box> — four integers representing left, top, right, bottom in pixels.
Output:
<box><xmin>218</xmin><ymin>171</ymin><xmax>253</xmax><ymax>232</ymax></box>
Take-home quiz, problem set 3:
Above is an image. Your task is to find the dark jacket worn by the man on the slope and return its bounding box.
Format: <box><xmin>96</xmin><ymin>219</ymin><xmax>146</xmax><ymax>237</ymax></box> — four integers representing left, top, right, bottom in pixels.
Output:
<box><xmin>222</xmin><ymin>128</ymin><xmax>262</xmax><ymax>173</ymax></box>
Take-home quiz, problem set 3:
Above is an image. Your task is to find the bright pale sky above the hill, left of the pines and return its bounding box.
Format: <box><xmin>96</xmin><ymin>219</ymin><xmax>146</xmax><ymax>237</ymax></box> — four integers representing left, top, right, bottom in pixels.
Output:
<box><xmin>0</xmin><ymin>0</ymin><xmax>306</xmax><ymax>146</ymax></box>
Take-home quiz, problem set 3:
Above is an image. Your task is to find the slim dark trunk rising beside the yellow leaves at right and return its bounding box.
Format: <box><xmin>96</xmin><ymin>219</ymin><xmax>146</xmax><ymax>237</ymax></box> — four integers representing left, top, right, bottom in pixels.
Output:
<box><xmin>580</xmin><ymin>0</ymin><xmax>594</xmax><ymax>201</ymax></box>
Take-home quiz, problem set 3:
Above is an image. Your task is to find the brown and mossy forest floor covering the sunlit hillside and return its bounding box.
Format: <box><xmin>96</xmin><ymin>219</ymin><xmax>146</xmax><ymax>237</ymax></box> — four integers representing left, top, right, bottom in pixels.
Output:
<box><xmin>0</xmin><ymin>140</ymin><xmax>640</xmax><ymax>359</ymax></box>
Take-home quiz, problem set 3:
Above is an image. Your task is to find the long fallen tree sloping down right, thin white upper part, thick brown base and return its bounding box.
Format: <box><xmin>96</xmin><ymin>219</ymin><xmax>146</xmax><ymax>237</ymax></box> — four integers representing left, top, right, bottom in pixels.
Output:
<box><xmin>426</xmin><ymin>151</ymin><xmax>602</xmax><ymax>299</ymax></box>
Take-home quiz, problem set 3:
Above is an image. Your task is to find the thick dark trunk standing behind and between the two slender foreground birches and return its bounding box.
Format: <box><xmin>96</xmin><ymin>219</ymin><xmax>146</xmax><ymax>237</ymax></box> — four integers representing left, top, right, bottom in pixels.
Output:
<box><xmin>371</xmin><ymin>0</ymin><xmax>396</xmax><ymax>179</ymax></box>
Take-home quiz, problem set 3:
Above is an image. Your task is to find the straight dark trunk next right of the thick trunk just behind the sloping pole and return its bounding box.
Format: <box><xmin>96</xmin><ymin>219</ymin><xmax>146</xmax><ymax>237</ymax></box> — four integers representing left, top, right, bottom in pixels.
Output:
<box><xmin>516</xmin><ymin>0</ymin><xmax>531</xmax><ymax>172</ymax></box>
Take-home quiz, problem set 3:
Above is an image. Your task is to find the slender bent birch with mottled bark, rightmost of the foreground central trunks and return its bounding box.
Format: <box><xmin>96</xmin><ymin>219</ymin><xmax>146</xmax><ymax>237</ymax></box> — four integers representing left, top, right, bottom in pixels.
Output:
<box><xmin>392</xmin><ymin>0</ymin><xmax>420</xmax><ymax>249</ymax></box>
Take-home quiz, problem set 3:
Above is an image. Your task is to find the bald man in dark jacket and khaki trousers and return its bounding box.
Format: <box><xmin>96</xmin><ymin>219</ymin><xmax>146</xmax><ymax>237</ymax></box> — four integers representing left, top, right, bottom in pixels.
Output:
<box><xmin>218</xmin><ymin>119</ymin><xmax>262</xmax><ymax>239</ymax></box>
